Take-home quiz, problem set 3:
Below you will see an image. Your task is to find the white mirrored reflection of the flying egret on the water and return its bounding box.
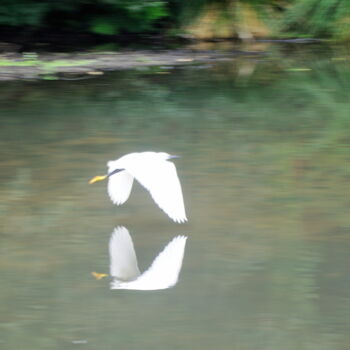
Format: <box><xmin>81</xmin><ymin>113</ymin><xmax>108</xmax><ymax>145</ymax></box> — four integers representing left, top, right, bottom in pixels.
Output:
<box><xmin>109</xmin><ymin>226</ymin><xmax>187</xmax><ymax>290</ymax></box>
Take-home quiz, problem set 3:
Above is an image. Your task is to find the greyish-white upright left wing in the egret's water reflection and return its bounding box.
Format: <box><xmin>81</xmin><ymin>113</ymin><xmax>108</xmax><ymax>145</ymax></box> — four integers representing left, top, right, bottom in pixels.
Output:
<box><xmin>109</xmin><ymin>226</ymin><xmax>140</xmax><ymax>281</ymax></box>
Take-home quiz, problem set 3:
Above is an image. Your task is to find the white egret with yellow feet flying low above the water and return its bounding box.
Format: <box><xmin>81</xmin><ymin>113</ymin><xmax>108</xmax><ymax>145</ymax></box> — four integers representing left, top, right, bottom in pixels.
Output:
<box><xmin>90</xmin><ymin>152</ymin><xmax>187</xmax><ymax>223</ymax></box>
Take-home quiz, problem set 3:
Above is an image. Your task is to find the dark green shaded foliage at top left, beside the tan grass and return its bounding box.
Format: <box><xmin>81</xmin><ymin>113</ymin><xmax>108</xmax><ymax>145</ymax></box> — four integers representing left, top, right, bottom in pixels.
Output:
<box><xmin>0</xmin><ymin>0</ymin><xmax>168</xmax><ymax>35</ymax></box>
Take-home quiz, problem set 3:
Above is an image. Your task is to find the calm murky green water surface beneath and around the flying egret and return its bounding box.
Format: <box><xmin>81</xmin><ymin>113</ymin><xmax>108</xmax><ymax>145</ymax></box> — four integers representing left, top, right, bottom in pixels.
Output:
<box><xmin>0</xmin><ymin>46</ymin><xmax>350</xmax><ymax>350</ymax></box>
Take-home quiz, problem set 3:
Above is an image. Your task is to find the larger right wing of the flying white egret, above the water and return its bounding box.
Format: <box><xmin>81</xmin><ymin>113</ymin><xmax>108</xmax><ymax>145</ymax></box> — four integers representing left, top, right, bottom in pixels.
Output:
<box><xmin>128</xmin><ymin>161</ymin><xmax>187</xmax><ymax>223</ymax></box>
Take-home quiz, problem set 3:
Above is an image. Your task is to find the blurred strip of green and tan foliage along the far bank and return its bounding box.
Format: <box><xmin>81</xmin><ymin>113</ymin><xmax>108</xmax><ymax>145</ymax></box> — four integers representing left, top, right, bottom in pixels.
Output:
<box><xmin>0</xmin><ymin>0</ymin><xmax>350</xmax><ymax>40</ymax></box>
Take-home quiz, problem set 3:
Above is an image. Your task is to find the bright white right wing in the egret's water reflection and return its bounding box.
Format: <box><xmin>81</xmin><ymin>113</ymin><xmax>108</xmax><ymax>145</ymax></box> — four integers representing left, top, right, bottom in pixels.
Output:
<box><xmin>122</xmin><ymin>236</ymin><xmax>187</xmax><ymax>290</ymax></box>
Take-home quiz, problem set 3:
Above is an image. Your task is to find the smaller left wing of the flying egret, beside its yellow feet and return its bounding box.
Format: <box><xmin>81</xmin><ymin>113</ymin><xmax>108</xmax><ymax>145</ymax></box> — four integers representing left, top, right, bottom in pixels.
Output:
<box><xmin>108</xmin><ymin>170</ymin><xmax>134</xmax><ymax>205</ymax></box>
